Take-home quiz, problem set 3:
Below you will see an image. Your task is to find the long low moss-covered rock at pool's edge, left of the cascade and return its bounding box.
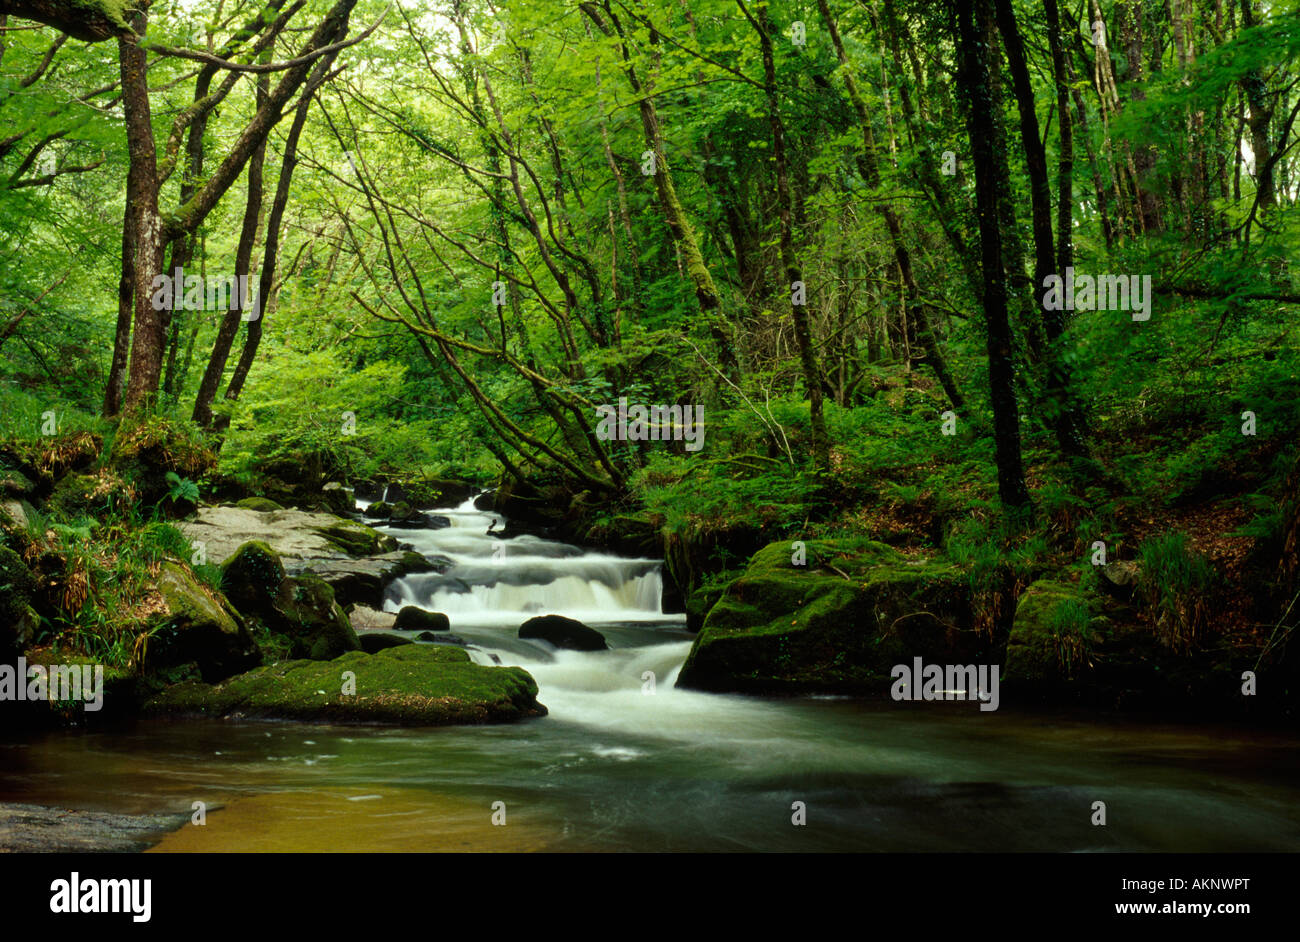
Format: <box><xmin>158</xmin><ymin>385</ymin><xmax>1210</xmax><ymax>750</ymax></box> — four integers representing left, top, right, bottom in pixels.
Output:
<box><xmin>146</xmin><ymin>644</ymin><xmax>546</xmax><ymax>726</ymax></box>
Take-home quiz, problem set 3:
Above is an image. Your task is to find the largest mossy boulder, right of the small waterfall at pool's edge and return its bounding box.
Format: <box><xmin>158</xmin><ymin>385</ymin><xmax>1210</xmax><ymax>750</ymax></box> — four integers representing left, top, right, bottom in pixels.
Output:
<box><xmin>677</xmin><ymin>541</ymin><xmax>992</xmax><ymax>694</ymax></box>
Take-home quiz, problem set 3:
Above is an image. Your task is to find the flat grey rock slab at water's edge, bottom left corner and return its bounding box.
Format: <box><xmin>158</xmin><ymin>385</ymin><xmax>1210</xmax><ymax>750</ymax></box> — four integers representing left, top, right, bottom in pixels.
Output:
<box><xmin>0</xmin><ymin>802</ymin><xmax>190</xmax><ymax>854</ymax></box>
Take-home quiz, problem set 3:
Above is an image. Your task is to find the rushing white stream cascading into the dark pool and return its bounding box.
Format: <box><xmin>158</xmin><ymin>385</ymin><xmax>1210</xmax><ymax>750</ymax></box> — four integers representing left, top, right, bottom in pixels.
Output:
<box><xmin>0</xmin><ymin>503</ymin><xmax>1300</xmax><ymax>851</ymax></box>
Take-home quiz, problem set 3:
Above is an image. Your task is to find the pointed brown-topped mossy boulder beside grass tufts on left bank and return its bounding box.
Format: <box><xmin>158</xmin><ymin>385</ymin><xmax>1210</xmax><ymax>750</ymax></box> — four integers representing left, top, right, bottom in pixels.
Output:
<box><xmin>144</xmin><ymin>563</ymin><xmax>261</xmax><ymax>682</ymax></box>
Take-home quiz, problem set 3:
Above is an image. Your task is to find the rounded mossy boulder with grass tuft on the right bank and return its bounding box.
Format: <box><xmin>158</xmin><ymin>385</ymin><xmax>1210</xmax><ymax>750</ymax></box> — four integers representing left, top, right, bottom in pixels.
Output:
<box><xmin>1002</xmin><ymin>579</ymin><xmax>1109</xmax><ymax>689</ymax></box>
